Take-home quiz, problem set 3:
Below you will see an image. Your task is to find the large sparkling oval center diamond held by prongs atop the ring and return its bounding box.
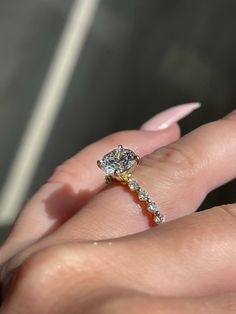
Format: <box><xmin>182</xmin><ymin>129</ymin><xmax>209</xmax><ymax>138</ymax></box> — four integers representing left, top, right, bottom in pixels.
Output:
<box><xmin>98</xmin><ymin>145</ymin><xmax>138</xmax><ymax>175</ymax></box>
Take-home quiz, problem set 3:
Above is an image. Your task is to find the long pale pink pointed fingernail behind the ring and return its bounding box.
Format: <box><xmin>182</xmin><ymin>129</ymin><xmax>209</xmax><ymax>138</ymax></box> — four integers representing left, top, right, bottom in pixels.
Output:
<box><xmin>141</xmin><ymin>102</ymin><xmax>201</xmax><ymax>131</ymax></box>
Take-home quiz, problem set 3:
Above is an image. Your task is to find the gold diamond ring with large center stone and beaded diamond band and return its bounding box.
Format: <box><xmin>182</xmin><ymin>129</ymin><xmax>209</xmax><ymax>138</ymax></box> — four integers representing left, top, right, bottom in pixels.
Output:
<box><xmin>97</xmin><ymin>145</ymin><xmax>165</xmax><ymax>224</ymax></box>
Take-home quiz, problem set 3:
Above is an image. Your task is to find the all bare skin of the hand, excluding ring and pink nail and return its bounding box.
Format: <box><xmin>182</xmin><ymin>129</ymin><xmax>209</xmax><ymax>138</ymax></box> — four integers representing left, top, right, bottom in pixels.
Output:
<box><xmin>0</xmin><ymin>111</ymin><xmax>236</xmax><ymax>314</ymax></box>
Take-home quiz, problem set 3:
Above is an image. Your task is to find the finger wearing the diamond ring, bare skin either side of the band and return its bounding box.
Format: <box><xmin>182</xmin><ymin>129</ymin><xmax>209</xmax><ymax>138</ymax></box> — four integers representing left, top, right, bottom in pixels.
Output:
<box><xmin>51</xmin><ymin>111</ymin><xmax>236</xmax><ymax>239</ymax></box>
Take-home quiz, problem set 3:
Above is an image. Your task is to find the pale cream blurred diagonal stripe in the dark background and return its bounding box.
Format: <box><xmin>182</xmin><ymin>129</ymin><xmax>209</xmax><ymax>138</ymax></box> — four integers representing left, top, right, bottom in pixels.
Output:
<box><xmin>0</xmin><ymin>0</ymin><xmax>99</xmax><ymax>225</ymax></box>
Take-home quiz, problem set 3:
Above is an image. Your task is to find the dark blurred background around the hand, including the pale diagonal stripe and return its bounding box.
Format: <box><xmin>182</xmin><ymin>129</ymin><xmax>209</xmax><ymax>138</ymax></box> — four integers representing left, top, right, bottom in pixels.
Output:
<box><xmin>0</xmin><ymin>0</ymin><xmax>236</xmax><ymax>241</ymax></box>
